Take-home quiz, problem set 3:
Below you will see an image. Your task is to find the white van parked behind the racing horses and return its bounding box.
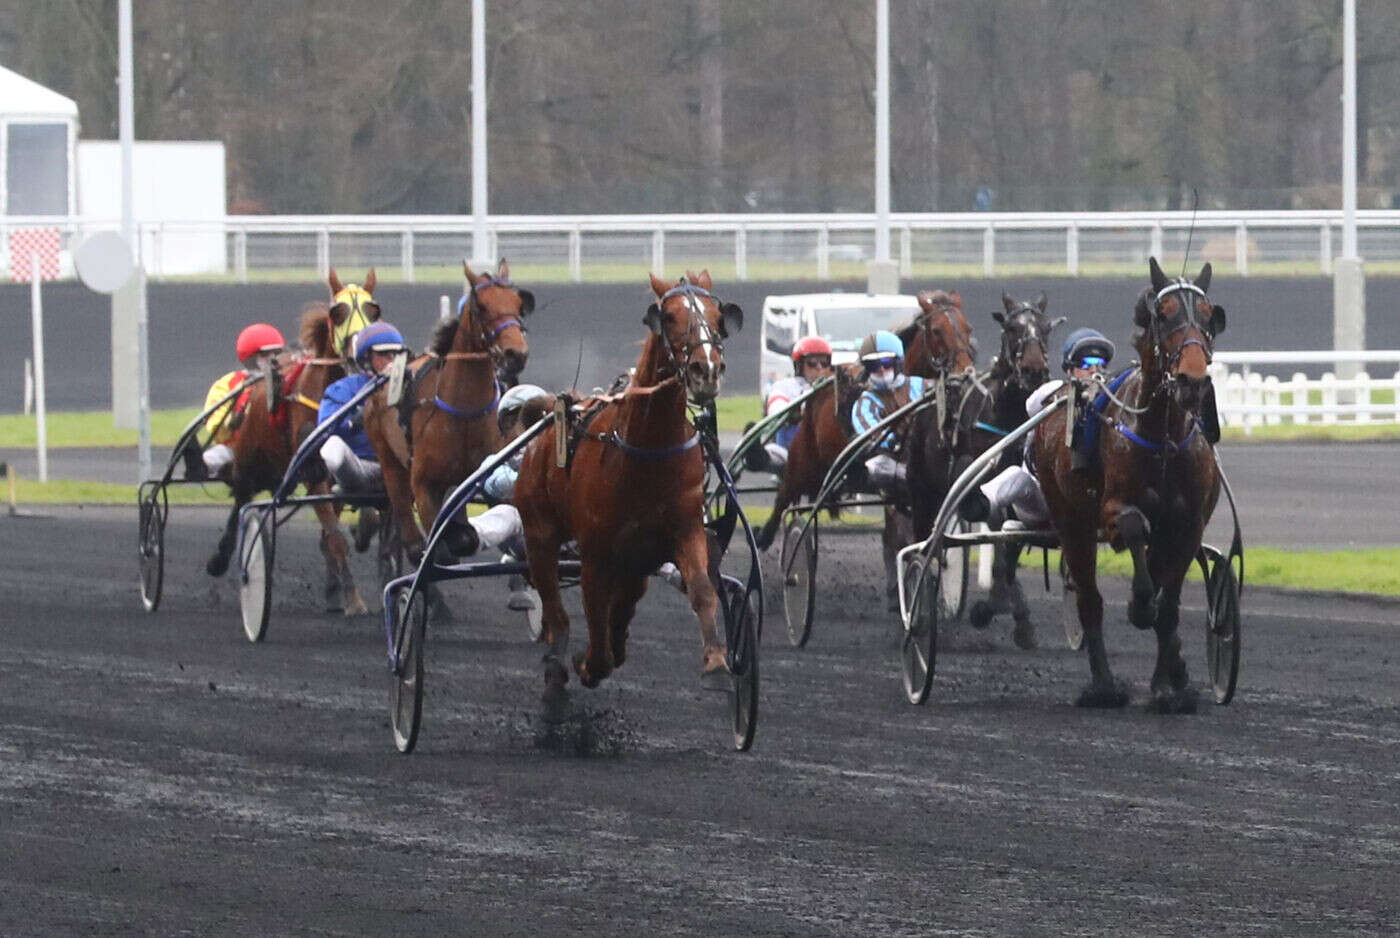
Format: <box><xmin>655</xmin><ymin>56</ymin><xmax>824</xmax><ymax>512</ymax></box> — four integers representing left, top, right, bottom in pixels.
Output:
<box><xmin>759</xmin><ymin>293</ymin><xmax>918</xmax><ymax>400</ymax></box>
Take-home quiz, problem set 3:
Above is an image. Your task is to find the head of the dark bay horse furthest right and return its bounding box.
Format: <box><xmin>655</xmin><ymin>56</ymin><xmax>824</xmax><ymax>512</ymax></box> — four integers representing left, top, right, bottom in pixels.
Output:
<box><xmin>1133</xmin><ymin>258</ymin><xmax>1225</xmax><ymax>413</ymax></box>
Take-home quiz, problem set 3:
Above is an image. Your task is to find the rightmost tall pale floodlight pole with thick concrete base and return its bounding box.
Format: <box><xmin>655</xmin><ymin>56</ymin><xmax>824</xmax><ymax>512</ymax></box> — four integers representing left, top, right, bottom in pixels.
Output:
<box><xmin>1331</xmin><ymin>0</ymin><xmax>1366</xmax><ymax>386</ymax></box>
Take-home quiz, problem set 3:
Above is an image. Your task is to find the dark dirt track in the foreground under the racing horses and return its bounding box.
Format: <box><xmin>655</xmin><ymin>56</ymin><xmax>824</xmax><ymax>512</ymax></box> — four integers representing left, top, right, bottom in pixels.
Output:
<box><xmin>0</xmin><ymin>508</ymin><xmax>1400</xmax><ymax>935</ymax></box>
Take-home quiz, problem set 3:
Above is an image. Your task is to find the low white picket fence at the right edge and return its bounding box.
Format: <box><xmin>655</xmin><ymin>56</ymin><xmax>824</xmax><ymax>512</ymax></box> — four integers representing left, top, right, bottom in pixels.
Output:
<box><xmin>1211</xmin><ymin>350</ymin><xmax>1400</xmax><ymax>434</ymax></box>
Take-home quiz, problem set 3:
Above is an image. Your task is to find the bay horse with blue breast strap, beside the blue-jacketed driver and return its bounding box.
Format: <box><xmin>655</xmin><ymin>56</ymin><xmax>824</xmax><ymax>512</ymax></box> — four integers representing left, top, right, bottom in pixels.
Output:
<box><xmin>364</xmin><ymin>259</ymin><xmax>535</xmax><ymax>556</ymax></box>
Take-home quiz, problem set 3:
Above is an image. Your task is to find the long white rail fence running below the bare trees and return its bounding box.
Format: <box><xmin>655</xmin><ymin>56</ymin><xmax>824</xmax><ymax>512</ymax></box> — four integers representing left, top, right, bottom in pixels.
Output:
<box><xmin>0</xmin><ymin>210</ymin><xmax>1400</xmax><ymax>283</ymax></box>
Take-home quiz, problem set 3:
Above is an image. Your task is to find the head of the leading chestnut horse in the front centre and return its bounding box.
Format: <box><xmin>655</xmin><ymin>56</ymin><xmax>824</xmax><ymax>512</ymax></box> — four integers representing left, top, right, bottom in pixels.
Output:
<box><xmin>637</xmin><ymin>270</ymin><xmax>743</xmax><ymax>403</ymax></box>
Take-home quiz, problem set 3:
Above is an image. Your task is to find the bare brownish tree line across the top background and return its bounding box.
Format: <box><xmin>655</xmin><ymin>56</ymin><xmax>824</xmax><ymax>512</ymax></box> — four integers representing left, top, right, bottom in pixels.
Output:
<box><xmin>0</xmin><ymin>0</ymin><xmax>1400</xmax><ymax>214</ymax></box>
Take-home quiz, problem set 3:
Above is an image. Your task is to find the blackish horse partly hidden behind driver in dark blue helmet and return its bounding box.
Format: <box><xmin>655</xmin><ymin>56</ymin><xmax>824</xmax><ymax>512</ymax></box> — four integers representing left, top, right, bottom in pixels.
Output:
<box><xmin>968</xmin><ymin>293</ymin><xmax>1065</xmax><ymax>650</ymax></box>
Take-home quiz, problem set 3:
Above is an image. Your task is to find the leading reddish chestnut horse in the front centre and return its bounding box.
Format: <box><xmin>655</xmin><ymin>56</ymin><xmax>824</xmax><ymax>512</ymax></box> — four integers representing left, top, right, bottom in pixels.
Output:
<box><xmin>515</xmin><ymin>270</ymin><xmax>743</xmax><ymax>701</ymax></box>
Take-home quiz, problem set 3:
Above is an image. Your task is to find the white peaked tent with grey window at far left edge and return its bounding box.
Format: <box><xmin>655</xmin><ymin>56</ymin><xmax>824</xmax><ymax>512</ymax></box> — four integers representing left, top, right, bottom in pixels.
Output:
<box><xmin>0</xmin><ymin>66</ymin><xmax>78</xmax><ymax>216</ymax></box>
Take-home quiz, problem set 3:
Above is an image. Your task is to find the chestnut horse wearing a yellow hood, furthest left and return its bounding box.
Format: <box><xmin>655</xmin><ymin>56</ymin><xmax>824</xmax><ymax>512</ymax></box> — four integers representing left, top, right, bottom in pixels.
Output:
<box><xmin>206</xmin><ymin>269</ymin><xmax>379</xmax><ymax>616</ymax></box>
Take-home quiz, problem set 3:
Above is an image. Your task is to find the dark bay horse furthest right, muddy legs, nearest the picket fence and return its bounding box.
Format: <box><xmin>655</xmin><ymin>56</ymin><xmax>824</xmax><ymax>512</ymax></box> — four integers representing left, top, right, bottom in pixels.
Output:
<box><xmin>1032</xmin><ymin>258</ymin><xmax>1225</xmax><ymax>713</ymax></box>
